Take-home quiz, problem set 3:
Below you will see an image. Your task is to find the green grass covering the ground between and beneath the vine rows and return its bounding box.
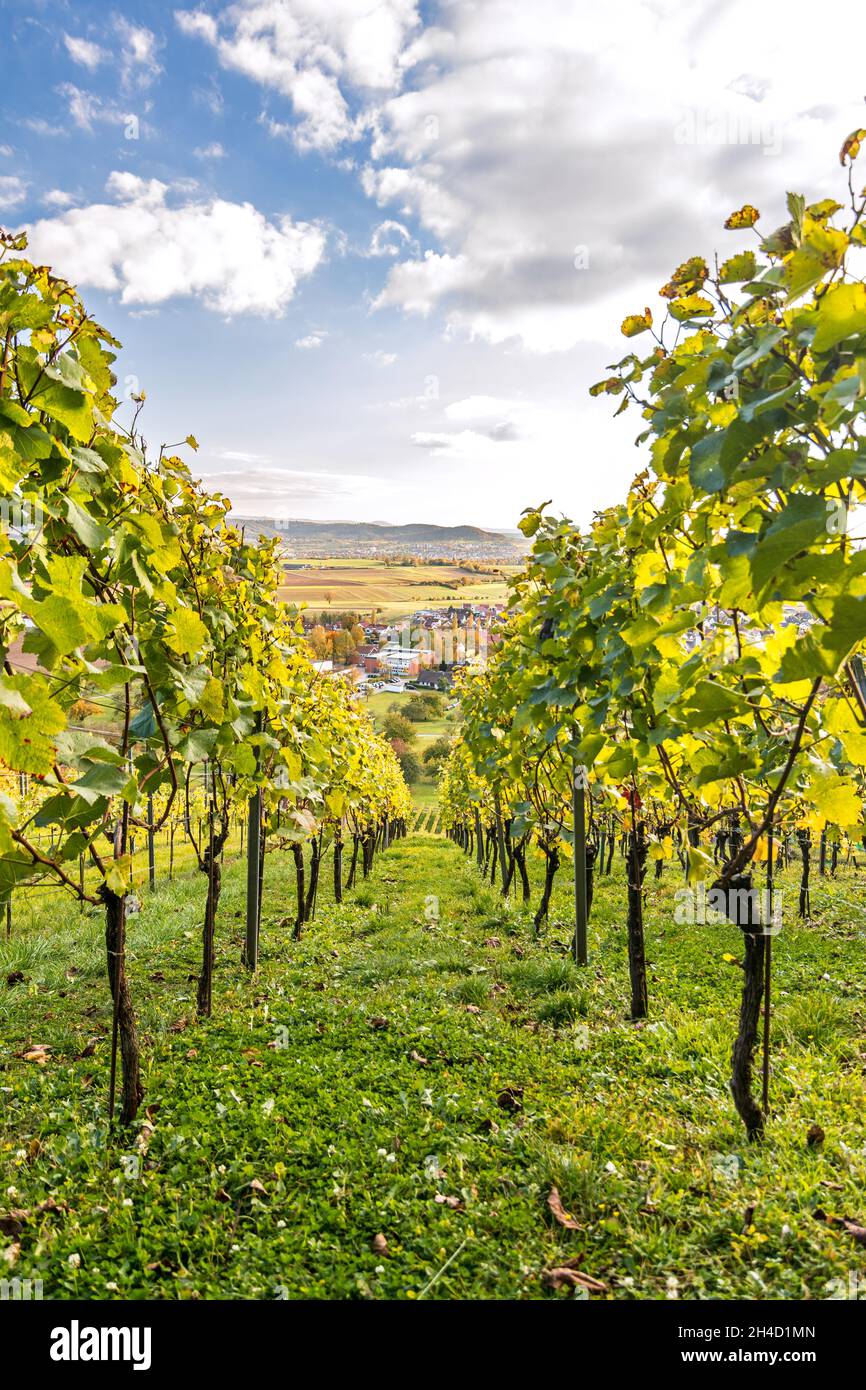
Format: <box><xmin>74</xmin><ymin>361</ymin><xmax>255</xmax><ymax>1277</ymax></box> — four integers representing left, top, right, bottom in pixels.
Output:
<box><xmin>0</xmin><ymin>834</ymin><xmax>866</xmax><ymax>1300</ymax></box>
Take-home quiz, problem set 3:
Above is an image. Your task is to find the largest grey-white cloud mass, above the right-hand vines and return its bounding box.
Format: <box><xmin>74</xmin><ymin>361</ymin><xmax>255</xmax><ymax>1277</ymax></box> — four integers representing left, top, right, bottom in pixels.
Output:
<box><xmin>361</xmin><ymin>0</ymin><xmax>862</xmax><ymax>352</ymax></box>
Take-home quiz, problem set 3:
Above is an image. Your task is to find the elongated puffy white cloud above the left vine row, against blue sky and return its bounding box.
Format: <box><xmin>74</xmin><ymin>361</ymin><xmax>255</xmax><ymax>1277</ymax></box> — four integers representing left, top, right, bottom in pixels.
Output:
<box><xmin>29</xmin><ymin>172</ymin><xmax>325</xmax><ymax>316</ymax></box>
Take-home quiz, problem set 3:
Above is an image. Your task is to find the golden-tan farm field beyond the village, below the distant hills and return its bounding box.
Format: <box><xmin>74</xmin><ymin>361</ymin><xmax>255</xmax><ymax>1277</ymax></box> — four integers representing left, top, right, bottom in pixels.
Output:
<box><xmin>279</xmin><ymin>560</ymin><xmax>507</xmax><ymax>620</ymax></box>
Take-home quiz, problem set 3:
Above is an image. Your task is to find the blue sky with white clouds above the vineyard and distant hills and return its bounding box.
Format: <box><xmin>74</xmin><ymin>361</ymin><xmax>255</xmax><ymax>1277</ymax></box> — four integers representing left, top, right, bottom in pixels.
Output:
<box><xmin>0</xmin><ymin>0</ymin><xmax>865</xmax><ymax>525</ymax></box>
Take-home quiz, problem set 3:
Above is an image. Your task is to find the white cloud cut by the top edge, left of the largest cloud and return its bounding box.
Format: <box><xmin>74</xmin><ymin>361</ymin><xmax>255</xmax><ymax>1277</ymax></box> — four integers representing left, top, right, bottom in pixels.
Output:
<box><xmin>175</xmin><ymin>0</ymin><xmax>418</xmax><ymax>150</ymax></box>
